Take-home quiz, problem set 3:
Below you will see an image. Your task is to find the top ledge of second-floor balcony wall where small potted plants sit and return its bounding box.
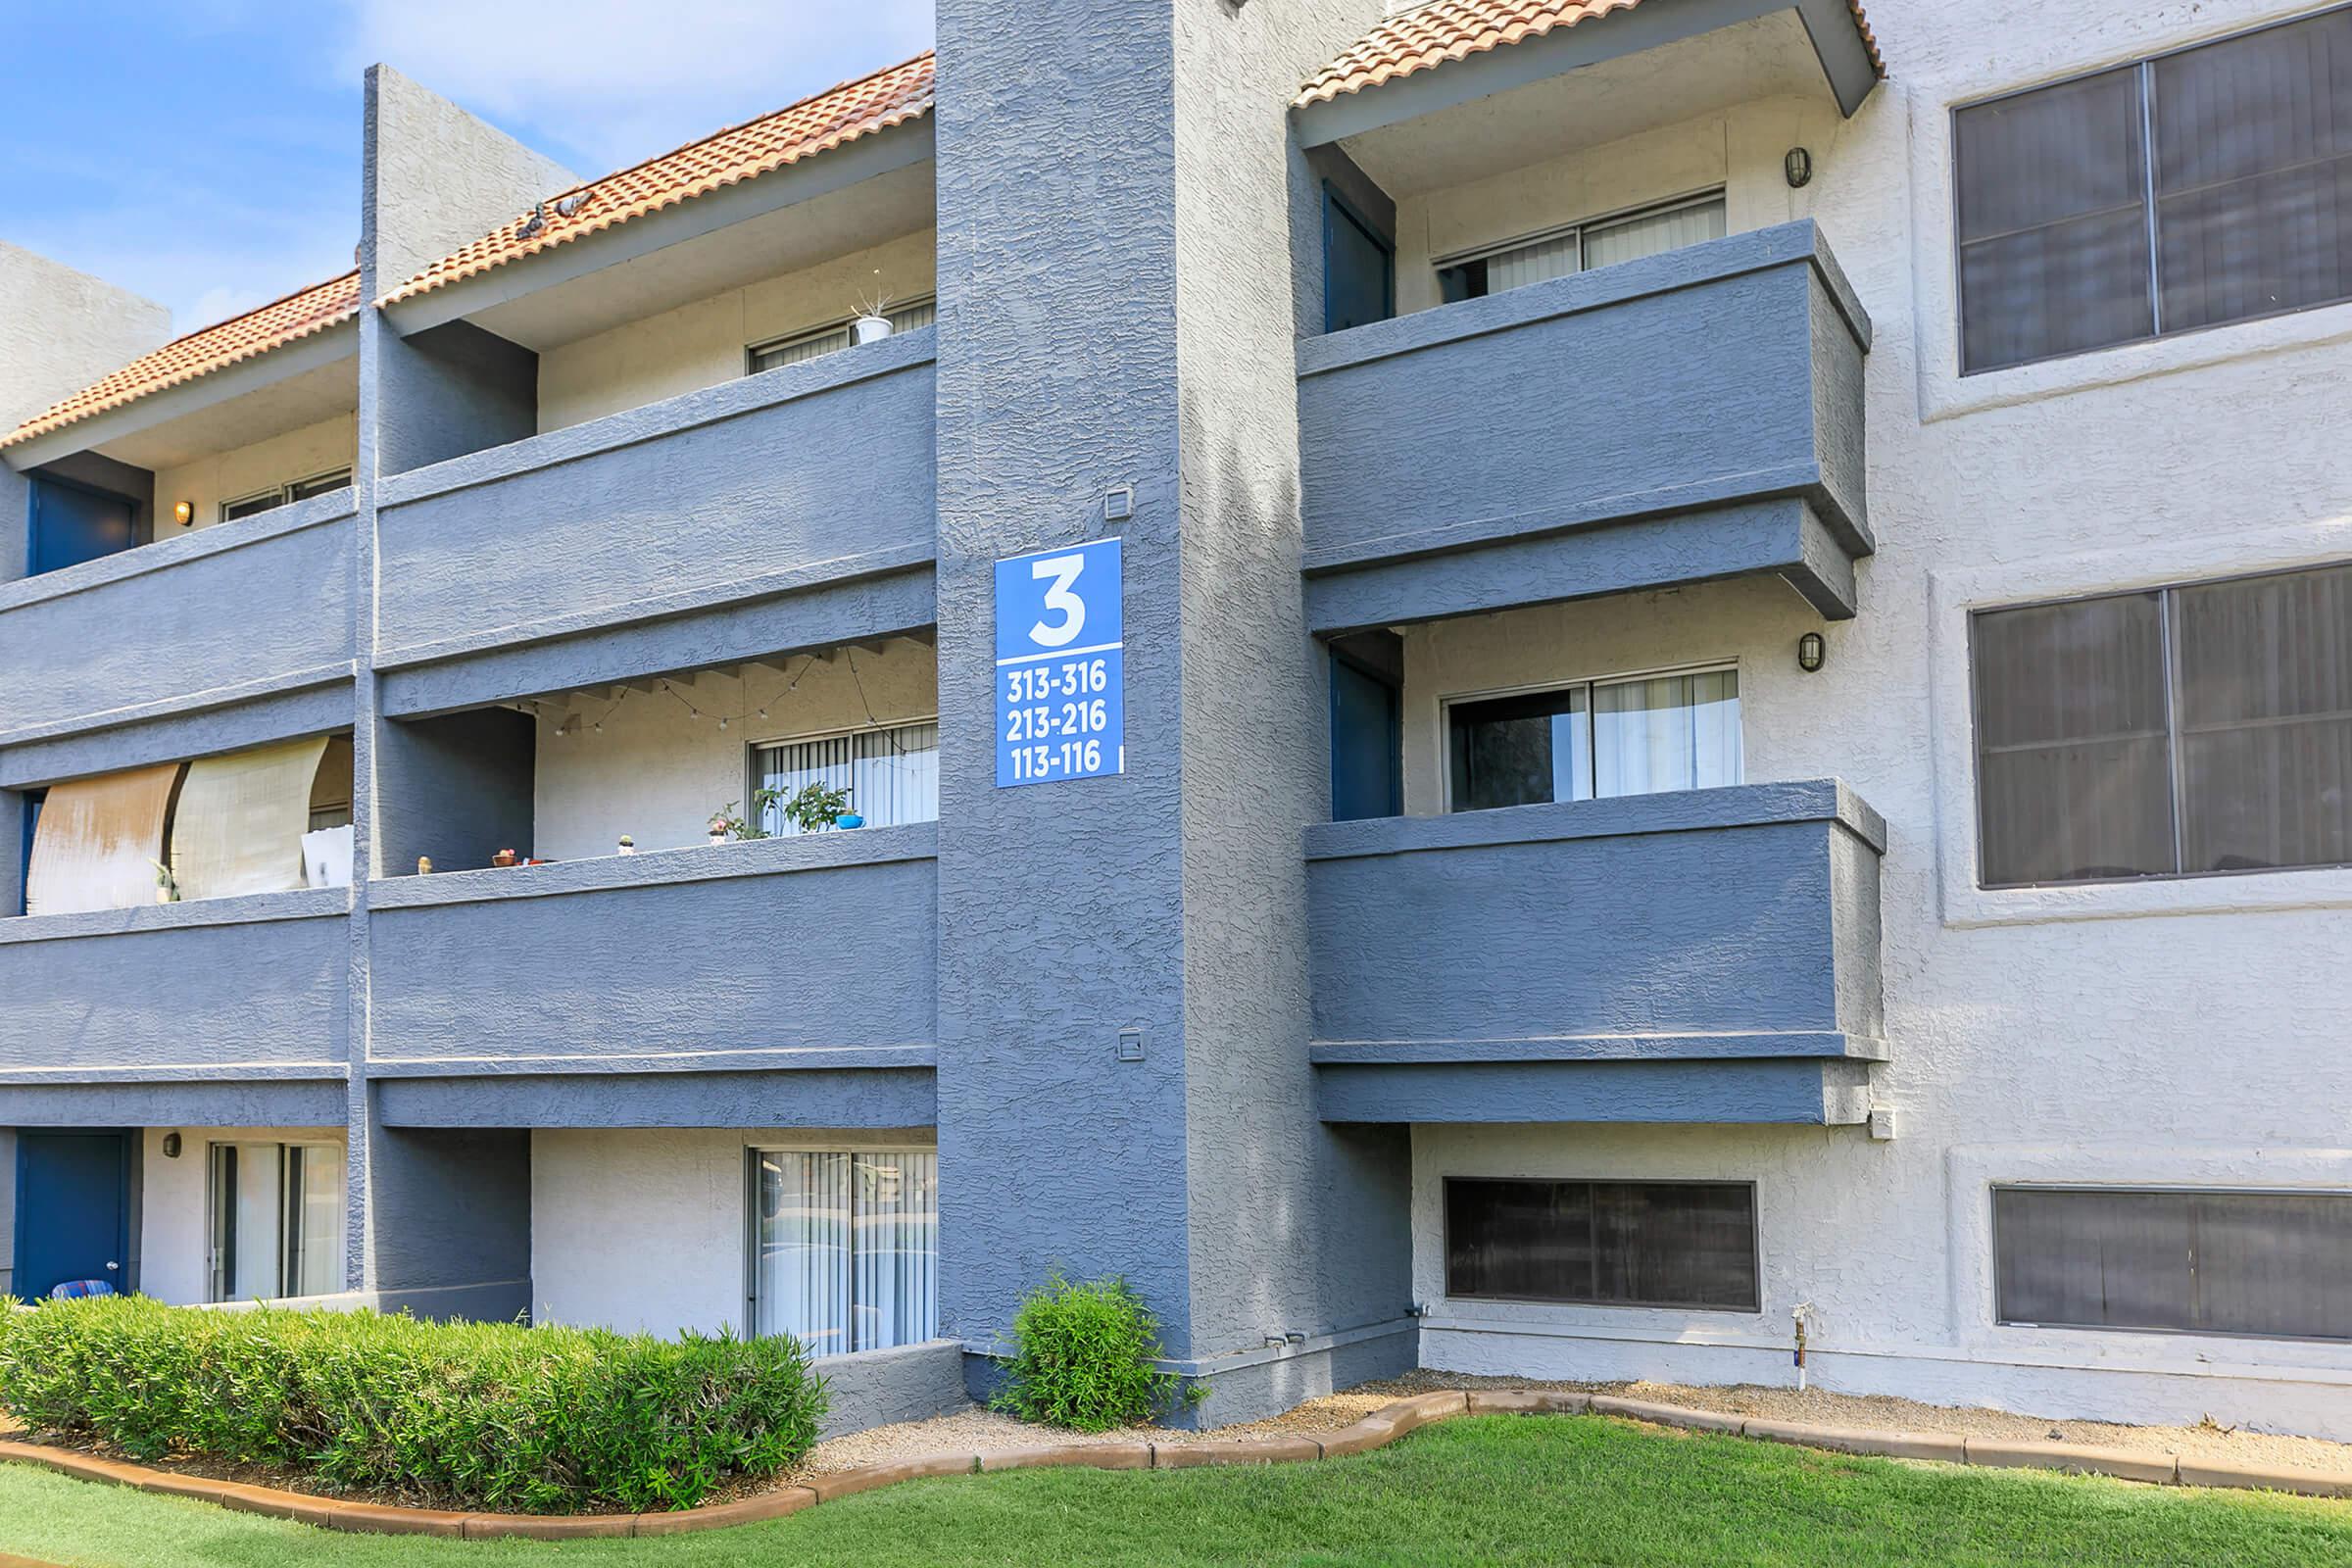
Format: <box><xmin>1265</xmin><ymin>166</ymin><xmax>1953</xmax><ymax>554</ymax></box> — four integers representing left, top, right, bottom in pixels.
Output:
<box><xmin>367</xmin><ymin>823</ymin><xmax>939</xmax><ymax>909</ymax></box>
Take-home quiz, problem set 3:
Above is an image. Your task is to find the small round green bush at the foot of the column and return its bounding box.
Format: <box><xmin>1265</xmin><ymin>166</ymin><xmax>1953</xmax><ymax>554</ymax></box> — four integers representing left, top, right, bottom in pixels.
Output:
<box><xmin>990</xmin><ymin>1274</ymin><xmax>1206</xmax><ymax>1432</ymax></box>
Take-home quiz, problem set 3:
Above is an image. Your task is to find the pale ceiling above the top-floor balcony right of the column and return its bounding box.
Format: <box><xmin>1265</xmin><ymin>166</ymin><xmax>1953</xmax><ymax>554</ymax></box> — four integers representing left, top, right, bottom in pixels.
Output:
<box><xmin>1339</xmin><ymin>10</ymin><xmax>1830</xmax><ymax>197</ymax></box>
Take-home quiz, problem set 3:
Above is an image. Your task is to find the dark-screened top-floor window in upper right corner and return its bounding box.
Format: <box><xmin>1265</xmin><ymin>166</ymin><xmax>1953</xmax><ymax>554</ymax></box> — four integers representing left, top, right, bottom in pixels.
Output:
<box><xmin>1952</xmin><ymin>7</ymin><xmax>2352</xmax><ymax>373</ymax></box>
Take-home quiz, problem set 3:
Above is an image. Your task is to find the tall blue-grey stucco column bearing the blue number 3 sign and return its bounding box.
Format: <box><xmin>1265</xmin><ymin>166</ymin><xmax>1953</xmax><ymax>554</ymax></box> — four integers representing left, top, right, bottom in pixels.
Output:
<box><xmin>939</xmin><ymin>0</ymin><xmax>1413</xmax><ymax>1422</ymax></box>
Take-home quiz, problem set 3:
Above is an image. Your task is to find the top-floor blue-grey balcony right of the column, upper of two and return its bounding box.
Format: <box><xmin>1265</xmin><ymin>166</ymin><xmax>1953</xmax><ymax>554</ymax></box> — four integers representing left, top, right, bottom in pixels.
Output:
<box><xmin>1298</xmin><ymin>220</ymin><xmax>1872</xmax><ymax>632</ymax></box>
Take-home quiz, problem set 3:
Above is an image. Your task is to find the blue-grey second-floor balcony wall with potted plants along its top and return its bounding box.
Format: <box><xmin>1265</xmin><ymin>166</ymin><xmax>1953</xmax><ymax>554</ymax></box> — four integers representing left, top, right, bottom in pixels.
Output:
<box><xmin>369</xmin><ymin>823</ymin><xmax>939</xmax><ymax>1126</ymax></box>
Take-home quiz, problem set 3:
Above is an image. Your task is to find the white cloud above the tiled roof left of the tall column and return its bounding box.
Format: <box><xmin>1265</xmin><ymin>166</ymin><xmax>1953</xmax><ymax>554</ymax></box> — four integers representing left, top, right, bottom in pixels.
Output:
<box><xmin>351</xmin><ymin>0</ymin><xmax>931</xmax><ymax>176</ymax></box>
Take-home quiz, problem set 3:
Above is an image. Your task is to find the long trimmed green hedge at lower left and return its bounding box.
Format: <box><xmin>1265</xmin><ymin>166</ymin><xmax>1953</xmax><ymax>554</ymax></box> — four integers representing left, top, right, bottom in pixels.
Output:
<box><xmin>0</xmin><ymin>1298</ymin><xmax>825</xmax><ymax>1514</ymax></box>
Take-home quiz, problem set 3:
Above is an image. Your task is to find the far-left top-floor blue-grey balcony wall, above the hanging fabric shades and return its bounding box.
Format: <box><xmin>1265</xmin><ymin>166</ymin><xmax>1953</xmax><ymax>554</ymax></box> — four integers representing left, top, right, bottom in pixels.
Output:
<box><xmin>0</xmin><ymin>489</ymin><xmax>353</xmax><ymax>750</ymax></box>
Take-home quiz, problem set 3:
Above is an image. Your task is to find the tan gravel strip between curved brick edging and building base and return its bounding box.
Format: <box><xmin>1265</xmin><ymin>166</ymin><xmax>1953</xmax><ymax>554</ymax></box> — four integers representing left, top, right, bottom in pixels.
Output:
<box><xmin>800</xmin><ymin>1371</ymin><xmax>2352</xmax><ymax>1474</ymax></box>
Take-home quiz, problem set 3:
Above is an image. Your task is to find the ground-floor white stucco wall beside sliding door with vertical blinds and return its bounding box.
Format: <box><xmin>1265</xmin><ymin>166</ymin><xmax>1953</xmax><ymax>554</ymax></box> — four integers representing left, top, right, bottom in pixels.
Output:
<box><xmin>531</xmin><ymin>1128</ymin><xmax>936</xmax><ymax>1336</ymax></box>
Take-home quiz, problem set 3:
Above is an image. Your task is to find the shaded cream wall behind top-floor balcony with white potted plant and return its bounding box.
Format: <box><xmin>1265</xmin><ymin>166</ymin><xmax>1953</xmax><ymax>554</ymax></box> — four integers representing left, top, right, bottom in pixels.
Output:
<box><xmin>539</xmin><ymin>230</ymin><xmax>936</xmax><ymax>430</ymax></box>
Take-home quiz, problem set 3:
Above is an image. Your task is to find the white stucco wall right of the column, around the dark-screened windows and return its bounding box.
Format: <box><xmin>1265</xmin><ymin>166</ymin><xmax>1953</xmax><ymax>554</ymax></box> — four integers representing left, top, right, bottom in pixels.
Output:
<box><xmin>1399</xmin><ymin>0</ymin><xmax>2352</xmax><ymax>1437</ymax></box>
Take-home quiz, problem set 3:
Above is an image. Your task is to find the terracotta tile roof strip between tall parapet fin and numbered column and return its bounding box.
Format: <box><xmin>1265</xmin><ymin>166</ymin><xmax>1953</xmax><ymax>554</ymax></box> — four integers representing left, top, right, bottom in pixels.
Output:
<box><xmin>376</xmin><ymin>52</ymin><xmax>931</xmax><ymax>306</ymax></box>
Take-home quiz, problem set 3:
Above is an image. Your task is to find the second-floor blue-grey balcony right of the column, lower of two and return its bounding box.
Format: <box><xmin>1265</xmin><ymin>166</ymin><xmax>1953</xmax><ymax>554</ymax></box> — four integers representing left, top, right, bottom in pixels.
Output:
<box><xmin>1307</xmin><ymin>778</ymin><xmax>1886</xmax><ymax>1124</ymax></box>
